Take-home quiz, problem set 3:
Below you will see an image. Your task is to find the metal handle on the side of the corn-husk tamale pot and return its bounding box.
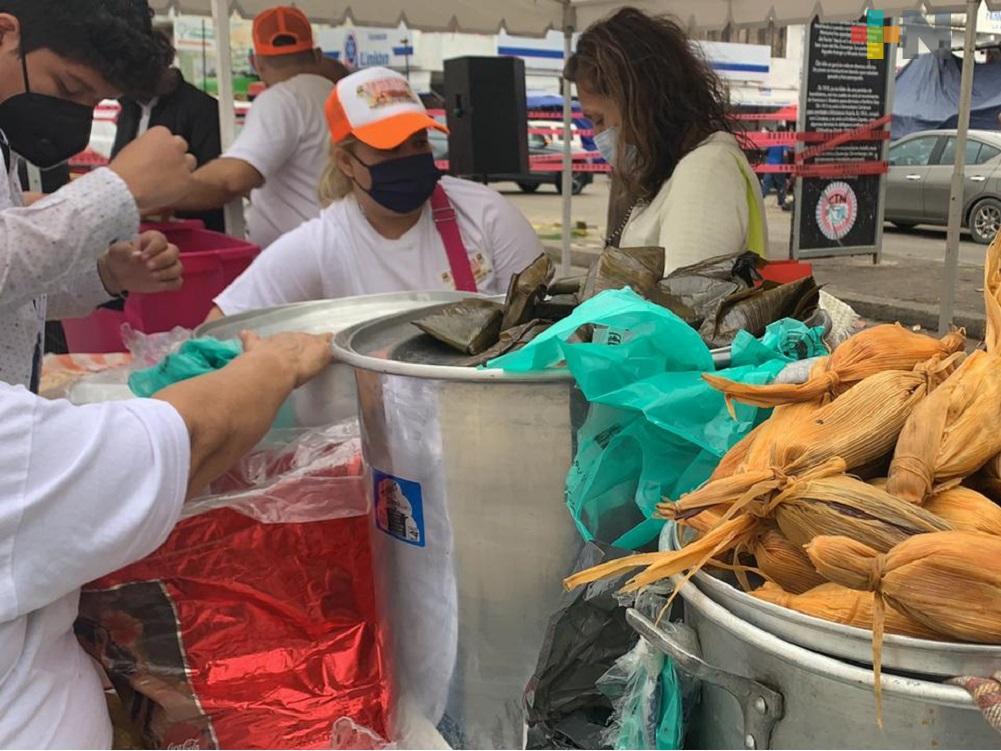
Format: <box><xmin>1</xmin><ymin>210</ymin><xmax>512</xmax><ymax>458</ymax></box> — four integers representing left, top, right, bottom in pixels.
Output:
<box><xmin>626</xmin><ymin>608</ymin><xmax>784</xmax><ymax>749</ymax></box>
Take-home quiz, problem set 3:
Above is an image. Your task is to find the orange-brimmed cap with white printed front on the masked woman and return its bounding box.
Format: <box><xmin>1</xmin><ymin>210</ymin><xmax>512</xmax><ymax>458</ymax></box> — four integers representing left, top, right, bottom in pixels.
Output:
<box><xmin>326</xmin><ymin>68</ymin><xmax>448</xmax><ymax>150</ymax></box>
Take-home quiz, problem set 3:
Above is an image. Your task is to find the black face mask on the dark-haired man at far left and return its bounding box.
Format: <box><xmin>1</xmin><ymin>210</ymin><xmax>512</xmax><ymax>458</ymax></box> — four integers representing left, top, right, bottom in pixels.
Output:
<box><xmin>0</xmin><ymin>50</ymin><xmax>94</xmax><ymax>169</ymax></box>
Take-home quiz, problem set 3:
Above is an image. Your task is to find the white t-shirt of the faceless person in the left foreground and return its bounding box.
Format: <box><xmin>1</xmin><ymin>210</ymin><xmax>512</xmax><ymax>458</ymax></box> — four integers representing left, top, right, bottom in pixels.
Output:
<box><xmin>0</xmin><ymin>385</ymin><xmax>190</xmax><ymax>748</ymax></box>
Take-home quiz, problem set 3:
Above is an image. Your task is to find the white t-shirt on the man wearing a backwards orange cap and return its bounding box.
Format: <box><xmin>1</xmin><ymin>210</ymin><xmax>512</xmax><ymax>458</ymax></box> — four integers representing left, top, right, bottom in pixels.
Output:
<box><xmin>223</xmin><ymin>73</ymin><xmax>333</xmax><ymax>247</ymax></box>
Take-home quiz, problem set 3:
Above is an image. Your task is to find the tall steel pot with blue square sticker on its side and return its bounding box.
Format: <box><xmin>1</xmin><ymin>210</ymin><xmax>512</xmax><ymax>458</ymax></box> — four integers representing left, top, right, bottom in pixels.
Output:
<box><xmin>334</xmin><ymin>311</ymin><xmax>580</xmax><ymax>748</ymax></box>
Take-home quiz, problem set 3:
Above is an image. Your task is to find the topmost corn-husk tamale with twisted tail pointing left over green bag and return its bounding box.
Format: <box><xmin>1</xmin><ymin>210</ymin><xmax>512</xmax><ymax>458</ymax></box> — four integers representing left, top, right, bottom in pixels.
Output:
<box><xmin>703</xmin><ymin>323</ymin><xmax>966</xmax><ymax>408</ymax></box>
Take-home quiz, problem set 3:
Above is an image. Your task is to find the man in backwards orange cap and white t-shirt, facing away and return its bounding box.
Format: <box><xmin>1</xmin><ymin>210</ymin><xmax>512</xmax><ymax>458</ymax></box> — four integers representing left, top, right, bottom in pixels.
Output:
<box><xmin>173</xmin><ymin>7</ymin><xmax>333</xmax><ymax>247</ymax></box>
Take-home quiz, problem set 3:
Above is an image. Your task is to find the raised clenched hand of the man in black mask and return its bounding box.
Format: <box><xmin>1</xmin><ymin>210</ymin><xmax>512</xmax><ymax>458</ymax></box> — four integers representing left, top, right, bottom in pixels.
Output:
<box><xmin>110</xmin><ymin>126</ymin><xmax>196</xmax><ymax>215</ymax></box>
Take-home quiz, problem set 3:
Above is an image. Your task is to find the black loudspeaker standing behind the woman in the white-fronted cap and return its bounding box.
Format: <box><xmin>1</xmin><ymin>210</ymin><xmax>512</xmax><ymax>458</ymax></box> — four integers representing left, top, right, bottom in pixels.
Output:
<box><xmin>444</xmin><ymin>57</ymin><xmax>529</xmax><ymax>177</ymax></box>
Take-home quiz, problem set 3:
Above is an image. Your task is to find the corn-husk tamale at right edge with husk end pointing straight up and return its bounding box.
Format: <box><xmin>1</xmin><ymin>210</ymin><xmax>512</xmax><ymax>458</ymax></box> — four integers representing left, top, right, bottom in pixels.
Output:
<box><xmin>887</xmin><ymin>236</ymin><xmax>1001</xmax><ymax>504</ymax></box>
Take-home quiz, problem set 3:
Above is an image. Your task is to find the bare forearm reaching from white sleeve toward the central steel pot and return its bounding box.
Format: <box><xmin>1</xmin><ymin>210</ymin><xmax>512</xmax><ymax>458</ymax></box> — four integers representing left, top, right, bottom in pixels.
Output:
<box><xmin>154</xmin><ymin>351</ymin><xmax>295</xmax><ymax>498</ymax></box>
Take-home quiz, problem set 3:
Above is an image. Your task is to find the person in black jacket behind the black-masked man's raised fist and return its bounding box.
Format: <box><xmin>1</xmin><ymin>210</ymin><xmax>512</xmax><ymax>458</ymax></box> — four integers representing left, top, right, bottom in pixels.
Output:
<box><xmin>111</xmin><ymin>68</ymin><xmax>226</xmax><ymax>232</ymax></box>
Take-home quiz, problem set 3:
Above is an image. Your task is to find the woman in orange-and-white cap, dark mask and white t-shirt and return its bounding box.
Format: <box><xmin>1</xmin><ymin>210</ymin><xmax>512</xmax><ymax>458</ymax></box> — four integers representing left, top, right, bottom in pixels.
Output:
<box><xmin>211</xmin><ymin>68</ymin><xmax>543</xmax><ymax>317</ymax></box>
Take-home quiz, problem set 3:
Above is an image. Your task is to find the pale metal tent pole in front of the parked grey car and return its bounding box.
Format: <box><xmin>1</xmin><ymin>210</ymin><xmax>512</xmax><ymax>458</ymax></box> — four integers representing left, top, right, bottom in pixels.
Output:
<box><xmin>939</xmin><ymin>0</ymin><xmax>980</xmax><ymax>334</ymax></box>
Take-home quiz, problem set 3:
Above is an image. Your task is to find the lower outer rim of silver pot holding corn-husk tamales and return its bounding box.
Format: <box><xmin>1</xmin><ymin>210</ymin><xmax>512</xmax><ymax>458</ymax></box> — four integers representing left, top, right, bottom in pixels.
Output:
<box><xmin>672</xmin><ymin>577</ymin><xmax>976</xmax><ymax>710</ymax></box>
